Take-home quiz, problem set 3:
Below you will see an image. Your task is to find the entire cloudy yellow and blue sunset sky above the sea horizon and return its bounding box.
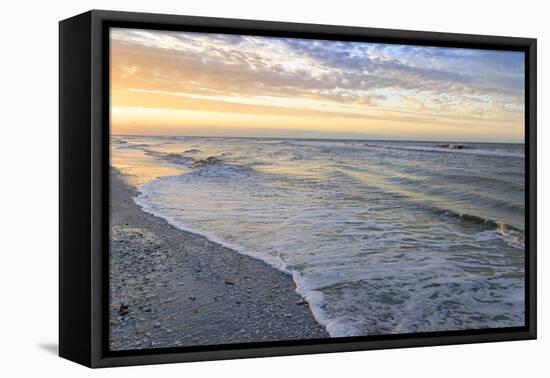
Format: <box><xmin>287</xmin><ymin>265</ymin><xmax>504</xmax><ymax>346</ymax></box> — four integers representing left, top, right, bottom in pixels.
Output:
<box><xmin>110</xmin><ymin>28</ymin><xmax>525</xmax><ymax>143</ymax></box>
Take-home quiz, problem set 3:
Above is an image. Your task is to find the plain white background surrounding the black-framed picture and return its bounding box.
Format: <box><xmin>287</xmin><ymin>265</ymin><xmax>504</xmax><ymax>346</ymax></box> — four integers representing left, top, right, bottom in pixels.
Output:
<box><xmin>0</xmin><ymin>0</ymin><xmax>550</xmax><ymax>378</ymax></box>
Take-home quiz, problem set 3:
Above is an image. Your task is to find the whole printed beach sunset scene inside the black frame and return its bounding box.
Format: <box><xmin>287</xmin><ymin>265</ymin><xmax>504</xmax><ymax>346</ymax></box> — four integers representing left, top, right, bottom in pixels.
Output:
<box><xmin>109</xmin><ymin>28</ymin><xmax>525</xmax><ymax>351</ymax></box>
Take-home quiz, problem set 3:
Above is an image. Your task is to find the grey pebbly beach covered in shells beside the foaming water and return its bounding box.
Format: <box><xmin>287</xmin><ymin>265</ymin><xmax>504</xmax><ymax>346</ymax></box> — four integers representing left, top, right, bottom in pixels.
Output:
<box><xmin>109</xmin><ymin>169</ymin><xmax>329</xmax><ymax>350</ymax></box>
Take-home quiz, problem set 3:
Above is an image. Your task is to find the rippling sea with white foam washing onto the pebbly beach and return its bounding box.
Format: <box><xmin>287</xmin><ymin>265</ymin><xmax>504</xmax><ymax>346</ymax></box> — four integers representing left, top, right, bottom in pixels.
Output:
<box><xmin>111</xmin><ymin>136</ymin><xmax>525</xmax><ymax>337</ymax></box>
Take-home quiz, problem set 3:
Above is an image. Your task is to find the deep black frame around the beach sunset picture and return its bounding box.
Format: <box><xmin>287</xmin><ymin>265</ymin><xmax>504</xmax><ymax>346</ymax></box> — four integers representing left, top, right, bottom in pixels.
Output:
<box><xmin>59</xmin><ymin>10</ymin><xmax>537</xmax><ymax>367</ymax></box>
